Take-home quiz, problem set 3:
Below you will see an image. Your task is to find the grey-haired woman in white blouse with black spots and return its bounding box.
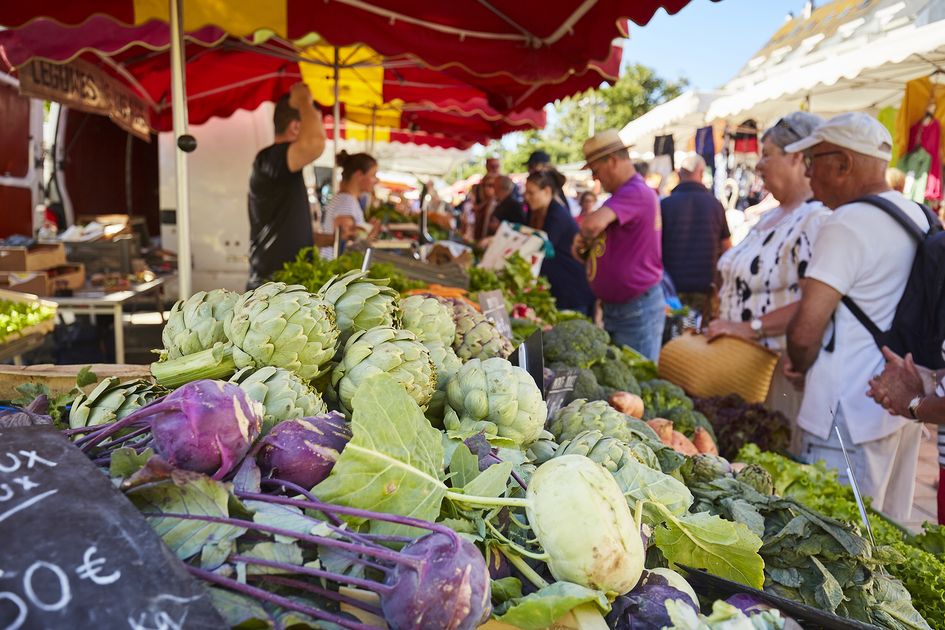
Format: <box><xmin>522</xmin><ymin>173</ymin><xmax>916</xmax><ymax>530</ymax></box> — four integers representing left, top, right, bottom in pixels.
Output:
<box><xmin>708</xmin><ymin>112</ymin><xmax>829</xmax><ymax>430</ymax></box>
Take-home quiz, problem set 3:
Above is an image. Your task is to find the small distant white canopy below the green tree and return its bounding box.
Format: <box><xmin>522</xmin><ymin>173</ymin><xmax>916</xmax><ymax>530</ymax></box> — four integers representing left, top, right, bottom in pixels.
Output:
<box><xmin>620</xmin><ymin>90</ymin><xmax>719</xmax><ymax>157</ymax></box>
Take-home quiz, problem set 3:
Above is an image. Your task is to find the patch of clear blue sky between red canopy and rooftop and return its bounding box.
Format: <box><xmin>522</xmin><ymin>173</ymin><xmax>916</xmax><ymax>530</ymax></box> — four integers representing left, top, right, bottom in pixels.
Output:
<box><xmin>623</xmin><ymin>0</ymin><xmax>808</xmax><ymax>89</ymax></box>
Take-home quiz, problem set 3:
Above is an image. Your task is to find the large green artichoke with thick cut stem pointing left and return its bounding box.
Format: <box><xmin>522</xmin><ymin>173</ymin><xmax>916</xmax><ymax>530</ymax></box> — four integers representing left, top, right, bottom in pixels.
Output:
<box><xmin>151</xmin><ymin>282</ymin><xmax>338</xmax><ymax>387</ymax></box>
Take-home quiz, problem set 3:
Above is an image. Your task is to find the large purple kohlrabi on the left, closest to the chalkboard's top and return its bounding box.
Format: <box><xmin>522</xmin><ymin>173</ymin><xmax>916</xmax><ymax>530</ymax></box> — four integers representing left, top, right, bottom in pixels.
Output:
<box><xmin>138</xmin><ymin>379</ymin><xmax>264</xmax><ymax>479</ymax></box>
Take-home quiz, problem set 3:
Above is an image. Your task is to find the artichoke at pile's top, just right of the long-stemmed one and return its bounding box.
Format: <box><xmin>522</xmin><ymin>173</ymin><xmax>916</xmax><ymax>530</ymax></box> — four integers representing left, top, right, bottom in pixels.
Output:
<box><xmin>318</xmin><ymin>269</ymin><xmax>398</xmax><ymax>346</ymax></box>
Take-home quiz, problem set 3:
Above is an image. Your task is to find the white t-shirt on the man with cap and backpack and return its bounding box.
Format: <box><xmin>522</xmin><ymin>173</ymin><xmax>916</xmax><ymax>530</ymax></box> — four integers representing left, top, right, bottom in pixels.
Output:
<box><xmin>797</xmin><ymin>191</ymin><xmax>929</xmax><ymax>444</ymax></box>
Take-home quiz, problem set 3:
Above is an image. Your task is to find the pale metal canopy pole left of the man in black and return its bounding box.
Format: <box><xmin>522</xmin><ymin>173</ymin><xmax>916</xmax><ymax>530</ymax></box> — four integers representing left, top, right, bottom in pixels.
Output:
<box><xmin>168</xmin><ymin>0</ymin><xmax>191</xmax><ymax>299</ymax></box>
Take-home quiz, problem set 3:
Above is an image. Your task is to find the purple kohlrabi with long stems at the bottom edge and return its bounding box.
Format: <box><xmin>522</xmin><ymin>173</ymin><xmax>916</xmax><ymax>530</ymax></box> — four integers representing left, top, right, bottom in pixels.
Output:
<box><xmin>381</xmin><ymin>533</ymin><xmax>492</xmax><ymax>630</ymax></box>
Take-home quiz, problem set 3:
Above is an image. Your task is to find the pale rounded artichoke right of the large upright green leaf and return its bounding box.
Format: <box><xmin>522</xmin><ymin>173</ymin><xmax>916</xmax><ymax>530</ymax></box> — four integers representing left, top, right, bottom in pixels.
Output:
<box><xmin>444</xmin><ymin>357</ymin><xmax>548</xmax><ymax>448</ymax></box>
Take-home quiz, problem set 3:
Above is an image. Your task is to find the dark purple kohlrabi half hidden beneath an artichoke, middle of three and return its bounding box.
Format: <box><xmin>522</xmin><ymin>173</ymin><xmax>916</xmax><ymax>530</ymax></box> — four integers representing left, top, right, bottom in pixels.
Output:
<box><xmin>256</xmin><ymin>411</ymin><xmax>351</xmax><ymax>489</ymax></box>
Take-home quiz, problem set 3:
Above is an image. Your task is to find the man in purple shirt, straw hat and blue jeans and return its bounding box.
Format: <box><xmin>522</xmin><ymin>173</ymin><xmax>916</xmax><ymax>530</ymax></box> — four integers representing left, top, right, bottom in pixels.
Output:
<box><xmin>573</xmin><ymin>129</ymin><xmax>666</xmax><ymax>361</ymax></box>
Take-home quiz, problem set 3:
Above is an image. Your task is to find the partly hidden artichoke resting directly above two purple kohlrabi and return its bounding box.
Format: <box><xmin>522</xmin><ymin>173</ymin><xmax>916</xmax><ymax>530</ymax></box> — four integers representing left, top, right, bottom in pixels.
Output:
<box><xmin>230</xmin><ymin>366</ymin><xmax>328</xmax><ymax>435</ymax></box>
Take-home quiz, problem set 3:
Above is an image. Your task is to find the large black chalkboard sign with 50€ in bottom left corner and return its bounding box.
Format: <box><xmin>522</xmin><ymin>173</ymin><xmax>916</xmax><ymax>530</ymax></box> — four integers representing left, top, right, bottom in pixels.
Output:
<box><xmin>0</xmin><ymin>427</ymin><xmax>225</xmax><ymax>630</ymax></box>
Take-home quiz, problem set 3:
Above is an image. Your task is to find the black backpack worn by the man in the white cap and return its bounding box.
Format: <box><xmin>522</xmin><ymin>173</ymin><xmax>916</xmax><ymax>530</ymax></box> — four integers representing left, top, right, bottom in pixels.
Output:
<box><xmin>827</xmin><ymin>195</ymin><xmax>945</xmax><ymax>370</ymax></box>
